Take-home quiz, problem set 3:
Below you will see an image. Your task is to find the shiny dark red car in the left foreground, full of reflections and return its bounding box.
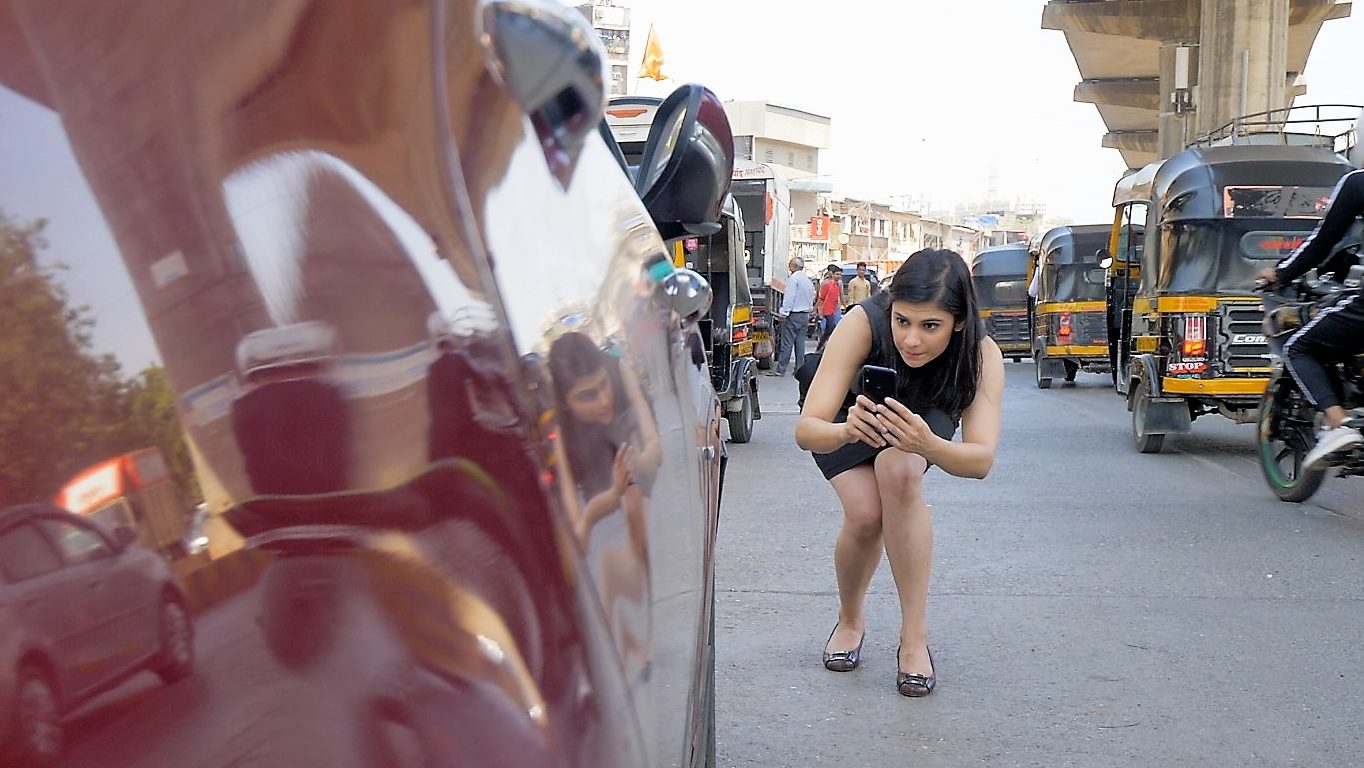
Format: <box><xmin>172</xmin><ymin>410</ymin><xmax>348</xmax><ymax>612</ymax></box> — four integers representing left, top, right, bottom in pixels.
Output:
<box><xmin>0</xmin><ymin>0</ymin><xmax>734</xmax><ymax>768</ymax></box>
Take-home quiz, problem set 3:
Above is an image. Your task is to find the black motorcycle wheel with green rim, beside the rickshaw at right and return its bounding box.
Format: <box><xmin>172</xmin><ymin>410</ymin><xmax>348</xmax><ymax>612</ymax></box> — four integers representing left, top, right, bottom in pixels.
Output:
<box><xmin>1255</xmin><ymin>385</ymin><xmax>1326</xmax><ymax>503</ymax></box>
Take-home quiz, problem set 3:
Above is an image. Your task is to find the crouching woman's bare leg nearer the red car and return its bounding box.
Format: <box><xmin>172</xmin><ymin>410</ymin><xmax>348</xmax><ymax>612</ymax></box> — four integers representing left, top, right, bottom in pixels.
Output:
<box><xmin>825</xmin><ymin>464</ymin><xmax>881</xmax><ymax>653</ymax></box>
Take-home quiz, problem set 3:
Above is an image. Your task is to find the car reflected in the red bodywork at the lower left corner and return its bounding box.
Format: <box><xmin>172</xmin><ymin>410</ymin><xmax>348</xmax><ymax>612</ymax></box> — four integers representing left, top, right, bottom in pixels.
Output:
<box><xmin>0</xmin><ymin>503</ymin><xmax>194</xmax><ymax>765</ymax></box>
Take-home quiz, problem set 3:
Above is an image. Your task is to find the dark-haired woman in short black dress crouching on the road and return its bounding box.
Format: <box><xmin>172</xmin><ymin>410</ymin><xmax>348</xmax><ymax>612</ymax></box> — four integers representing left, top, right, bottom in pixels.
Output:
<box><xmin>795</xmin><ymin>251</ymin><xmax>1004</xmax><ymax>696</ymax></box>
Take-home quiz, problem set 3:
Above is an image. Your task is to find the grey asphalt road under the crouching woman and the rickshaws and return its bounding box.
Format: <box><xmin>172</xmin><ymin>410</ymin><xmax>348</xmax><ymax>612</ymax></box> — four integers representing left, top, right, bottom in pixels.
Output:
<box><xmin>716</xmin><ymin>361</ymin><xmax>1364</xmax><ymax>768</ymax></box>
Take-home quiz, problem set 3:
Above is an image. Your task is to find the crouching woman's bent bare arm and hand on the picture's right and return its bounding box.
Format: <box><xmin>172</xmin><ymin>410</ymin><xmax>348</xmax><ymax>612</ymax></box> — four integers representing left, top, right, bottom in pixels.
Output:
<box><xmin>872</xmin><ymin>338</ymin><xmax>1004</xmax><ymax>479</ymax></box>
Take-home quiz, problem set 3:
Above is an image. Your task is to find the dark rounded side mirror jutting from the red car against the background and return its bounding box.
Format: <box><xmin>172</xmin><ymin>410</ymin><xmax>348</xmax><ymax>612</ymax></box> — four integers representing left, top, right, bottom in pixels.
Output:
<box><xmin>634</xmin><ymin>85</ymin><xmax>734</xmax><ymax>240</ymax></box>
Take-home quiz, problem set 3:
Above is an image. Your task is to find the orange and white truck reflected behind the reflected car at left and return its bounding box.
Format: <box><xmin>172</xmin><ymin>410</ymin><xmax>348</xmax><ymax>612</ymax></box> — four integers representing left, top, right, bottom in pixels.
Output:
<box><xmin>53</xmin><ymin>447</ymin><xmax>192</xmax><ymax>559</ymax></box>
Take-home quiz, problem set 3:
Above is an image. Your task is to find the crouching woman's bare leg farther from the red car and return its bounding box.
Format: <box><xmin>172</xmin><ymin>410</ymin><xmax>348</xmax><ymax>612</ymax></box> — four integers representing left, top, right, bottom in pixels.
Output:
<box><xmin>876</xmin><ymin>449</ymin><xmax>933</xmax><ymax>675</ymax></box>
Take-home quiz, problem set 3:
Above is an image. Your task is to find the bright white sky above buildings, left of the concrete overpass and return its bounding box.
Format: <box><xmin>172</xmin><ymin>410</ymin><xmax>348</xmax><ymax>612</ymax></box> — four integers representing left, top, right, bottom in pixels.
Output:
<box><xmin>617</xmin><ymin>0</ymin><xmax>1364</xmax><ymax>224</ymax></box>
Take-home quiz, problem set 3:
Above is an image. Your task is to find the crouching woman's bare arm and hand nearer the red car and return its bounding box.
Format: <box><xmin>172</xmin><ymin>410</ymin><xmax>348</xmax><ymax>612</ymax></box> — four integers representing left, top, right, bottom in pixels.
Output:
<box><xmin>795</xmin><ymin>307</ymin><xmax>885</xmax><ymax>453</ymax></box>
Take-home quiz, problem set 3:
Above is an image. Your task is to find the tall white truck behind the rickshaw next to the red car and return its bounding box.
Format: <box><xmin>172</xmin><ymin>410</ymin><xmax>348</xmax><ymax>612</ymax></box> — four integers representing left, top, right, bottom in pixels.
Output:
<box><xmin>730</xmin><ymin>160</ymin><xmax>791</xmax><ymax>368</ymax></box>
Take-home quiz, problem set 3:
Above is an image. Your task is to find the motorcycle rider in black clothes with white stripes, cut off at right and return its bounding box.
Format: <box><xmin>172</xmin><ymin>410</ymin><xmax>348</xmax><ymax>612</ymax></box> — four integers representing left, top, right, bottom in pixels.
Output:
<box><xmin>1256</xmin><ymin>163</ymin><xmax>1364</xmax><ymax>469</ymax></box>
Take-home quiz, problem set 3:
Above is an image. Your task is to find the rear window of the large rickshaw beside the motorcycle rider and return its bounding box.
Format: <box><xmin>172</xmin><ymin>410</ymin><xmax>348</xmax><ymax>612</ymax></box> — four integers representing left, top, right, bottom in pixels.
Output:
<box><xmin>1158</xmin><ymin>218</ymin><xmax>1316</xmax><ymax>293</ymax></box>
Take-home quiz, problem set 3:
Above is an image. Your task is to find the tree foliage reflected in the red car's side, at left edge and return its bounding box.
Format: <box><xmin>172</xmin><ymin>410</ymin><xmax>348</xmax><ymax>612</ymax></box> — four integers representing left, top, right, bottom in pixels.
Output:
<box><xmin>0</xmin><ymin>210</ymin><xmax>196</xmax><ymax>507</ymax></box>
